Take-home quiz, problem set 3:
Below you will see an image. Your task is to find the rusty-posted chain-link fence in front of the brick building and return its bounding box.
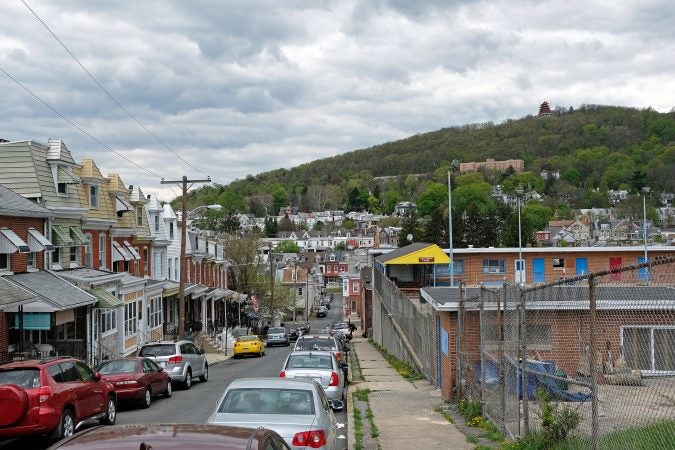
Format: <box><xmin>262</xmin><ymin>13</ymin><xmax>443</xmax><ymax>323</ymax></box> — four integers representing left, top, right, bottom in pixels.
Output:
<box><xmin>456</xmin><ymin>258</ymin><xmax>675</xmax><ymax>449</ymax></box>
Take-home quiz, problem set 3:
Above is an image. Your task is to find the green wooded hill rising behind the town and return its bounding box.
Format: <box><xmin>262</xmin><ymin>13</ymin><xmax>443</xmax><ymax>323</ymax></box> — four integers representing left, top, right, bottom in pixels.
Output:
<box><xmin>173</xmin><ymin>105</ymin><xmax>675</xmax><ymax>215</ymax></box>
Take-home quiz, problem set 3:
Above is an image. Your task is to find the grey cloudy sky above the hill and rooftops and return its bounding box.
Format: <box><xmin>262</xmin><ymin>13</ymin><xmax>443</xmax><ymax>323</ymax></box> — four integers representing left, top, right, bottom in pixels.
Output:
<box><xmin>0</xmin><ymin>0</ymin><xmax>675</xmax><ymax>200</ymax></box>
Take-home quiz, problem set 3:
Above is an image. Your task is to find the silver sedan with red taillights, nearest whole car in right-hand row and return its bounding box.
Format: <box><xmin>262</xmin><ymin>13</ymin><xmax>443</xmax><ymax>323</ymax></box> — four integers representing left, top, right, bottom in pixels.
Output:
<box><xmin>207</xmin><ymin>378</ymin><xmax>347</xmax><ymax>450</ymax></box>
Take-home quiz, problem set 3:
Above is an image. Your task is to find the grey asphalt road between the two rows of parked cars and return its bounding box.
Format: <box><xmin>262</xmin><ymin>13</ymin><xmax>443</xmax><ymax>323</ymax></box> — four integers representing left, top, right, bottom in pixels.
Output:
<box><xmin>0</xmin><ymin>294</ymin><xmax>347</xmax><ymax>450</ymax></box>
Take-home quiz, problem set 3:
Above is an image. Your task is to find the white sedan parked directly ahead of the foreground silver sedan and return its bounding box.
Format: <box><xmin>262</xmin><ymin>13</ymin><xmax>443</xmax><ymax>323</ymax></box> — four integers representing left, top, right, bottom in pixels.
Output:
<box><xmin>279</xmin><ymin>351</ymin><xmax>346</xmax><ymax>401</ymax></box>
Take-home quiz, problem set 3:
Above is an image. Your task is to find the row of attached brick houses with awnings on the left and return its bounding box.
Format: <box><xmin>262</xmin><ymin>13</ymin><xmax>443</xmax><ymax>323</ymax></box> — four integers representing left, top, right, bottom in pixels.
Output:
<box><xmin>0</xmin><ymin>139</ymin><xmax>234</xmax><ymax>362</ymax></box>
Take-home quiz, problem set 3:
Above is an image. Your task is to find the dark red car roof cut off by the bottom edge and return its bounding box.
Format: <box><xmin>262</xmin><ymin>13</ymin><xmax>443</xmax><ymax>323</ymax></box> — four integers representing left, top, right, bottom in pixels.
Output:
<box><xmin>48</xmin><ymin>423</ymin><xmax>290</xmax><ymax>450</ymax></box>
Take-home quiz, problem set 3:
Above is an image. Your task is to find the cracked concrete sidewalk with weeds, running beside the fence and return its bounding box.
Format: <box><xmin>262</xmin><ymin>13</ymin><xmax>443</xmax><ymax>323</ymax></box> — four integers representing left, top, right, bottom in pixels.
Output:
<box><xmin>350</xmin><ymin>337</ymin><xmax>473</xmax><ymax>450</ymax></box>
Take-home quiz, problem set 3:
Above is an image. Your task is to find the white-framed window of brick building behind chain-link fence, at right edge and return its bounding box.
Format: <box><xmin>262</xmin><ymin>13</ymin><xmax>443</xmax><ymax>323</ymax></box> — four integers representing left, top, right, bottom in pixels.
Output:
<box><xmin>621</xmin><ymin>325</ymin><xmax>675</xmax><ymax>373</ymax></box>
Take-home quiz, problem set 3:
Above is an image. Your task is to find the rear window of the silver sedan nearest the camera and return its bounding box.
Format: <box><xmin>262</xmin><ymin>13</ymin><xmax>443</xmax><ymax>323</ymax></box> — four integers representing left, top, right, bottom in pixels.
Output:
<box><xmin>218</xmin><ymin>388</ymin><xmax>314</xmax><ymax>415</ymax></box>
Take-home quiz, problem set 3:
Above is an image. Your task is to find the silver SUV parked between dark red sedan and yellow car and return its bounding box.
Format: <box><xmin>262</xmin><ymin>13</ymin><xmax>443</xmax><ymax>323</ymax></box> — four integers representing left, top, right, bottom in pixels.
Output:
<box><xmin>138</xmin><ymin>340</ymin><xmax>209</xmax><ymax>389</ymax></box>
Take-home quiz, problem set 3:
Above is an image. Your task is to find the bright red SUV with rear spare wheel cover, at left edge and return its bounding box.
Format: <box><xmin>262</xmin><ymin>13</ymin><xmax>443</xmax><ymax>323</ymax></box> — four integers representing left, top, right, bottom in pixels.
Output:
<box><xmin>0</xmin><ymin>357</ymin><xmax>117</xmax><ymax>440</ymax></box>
